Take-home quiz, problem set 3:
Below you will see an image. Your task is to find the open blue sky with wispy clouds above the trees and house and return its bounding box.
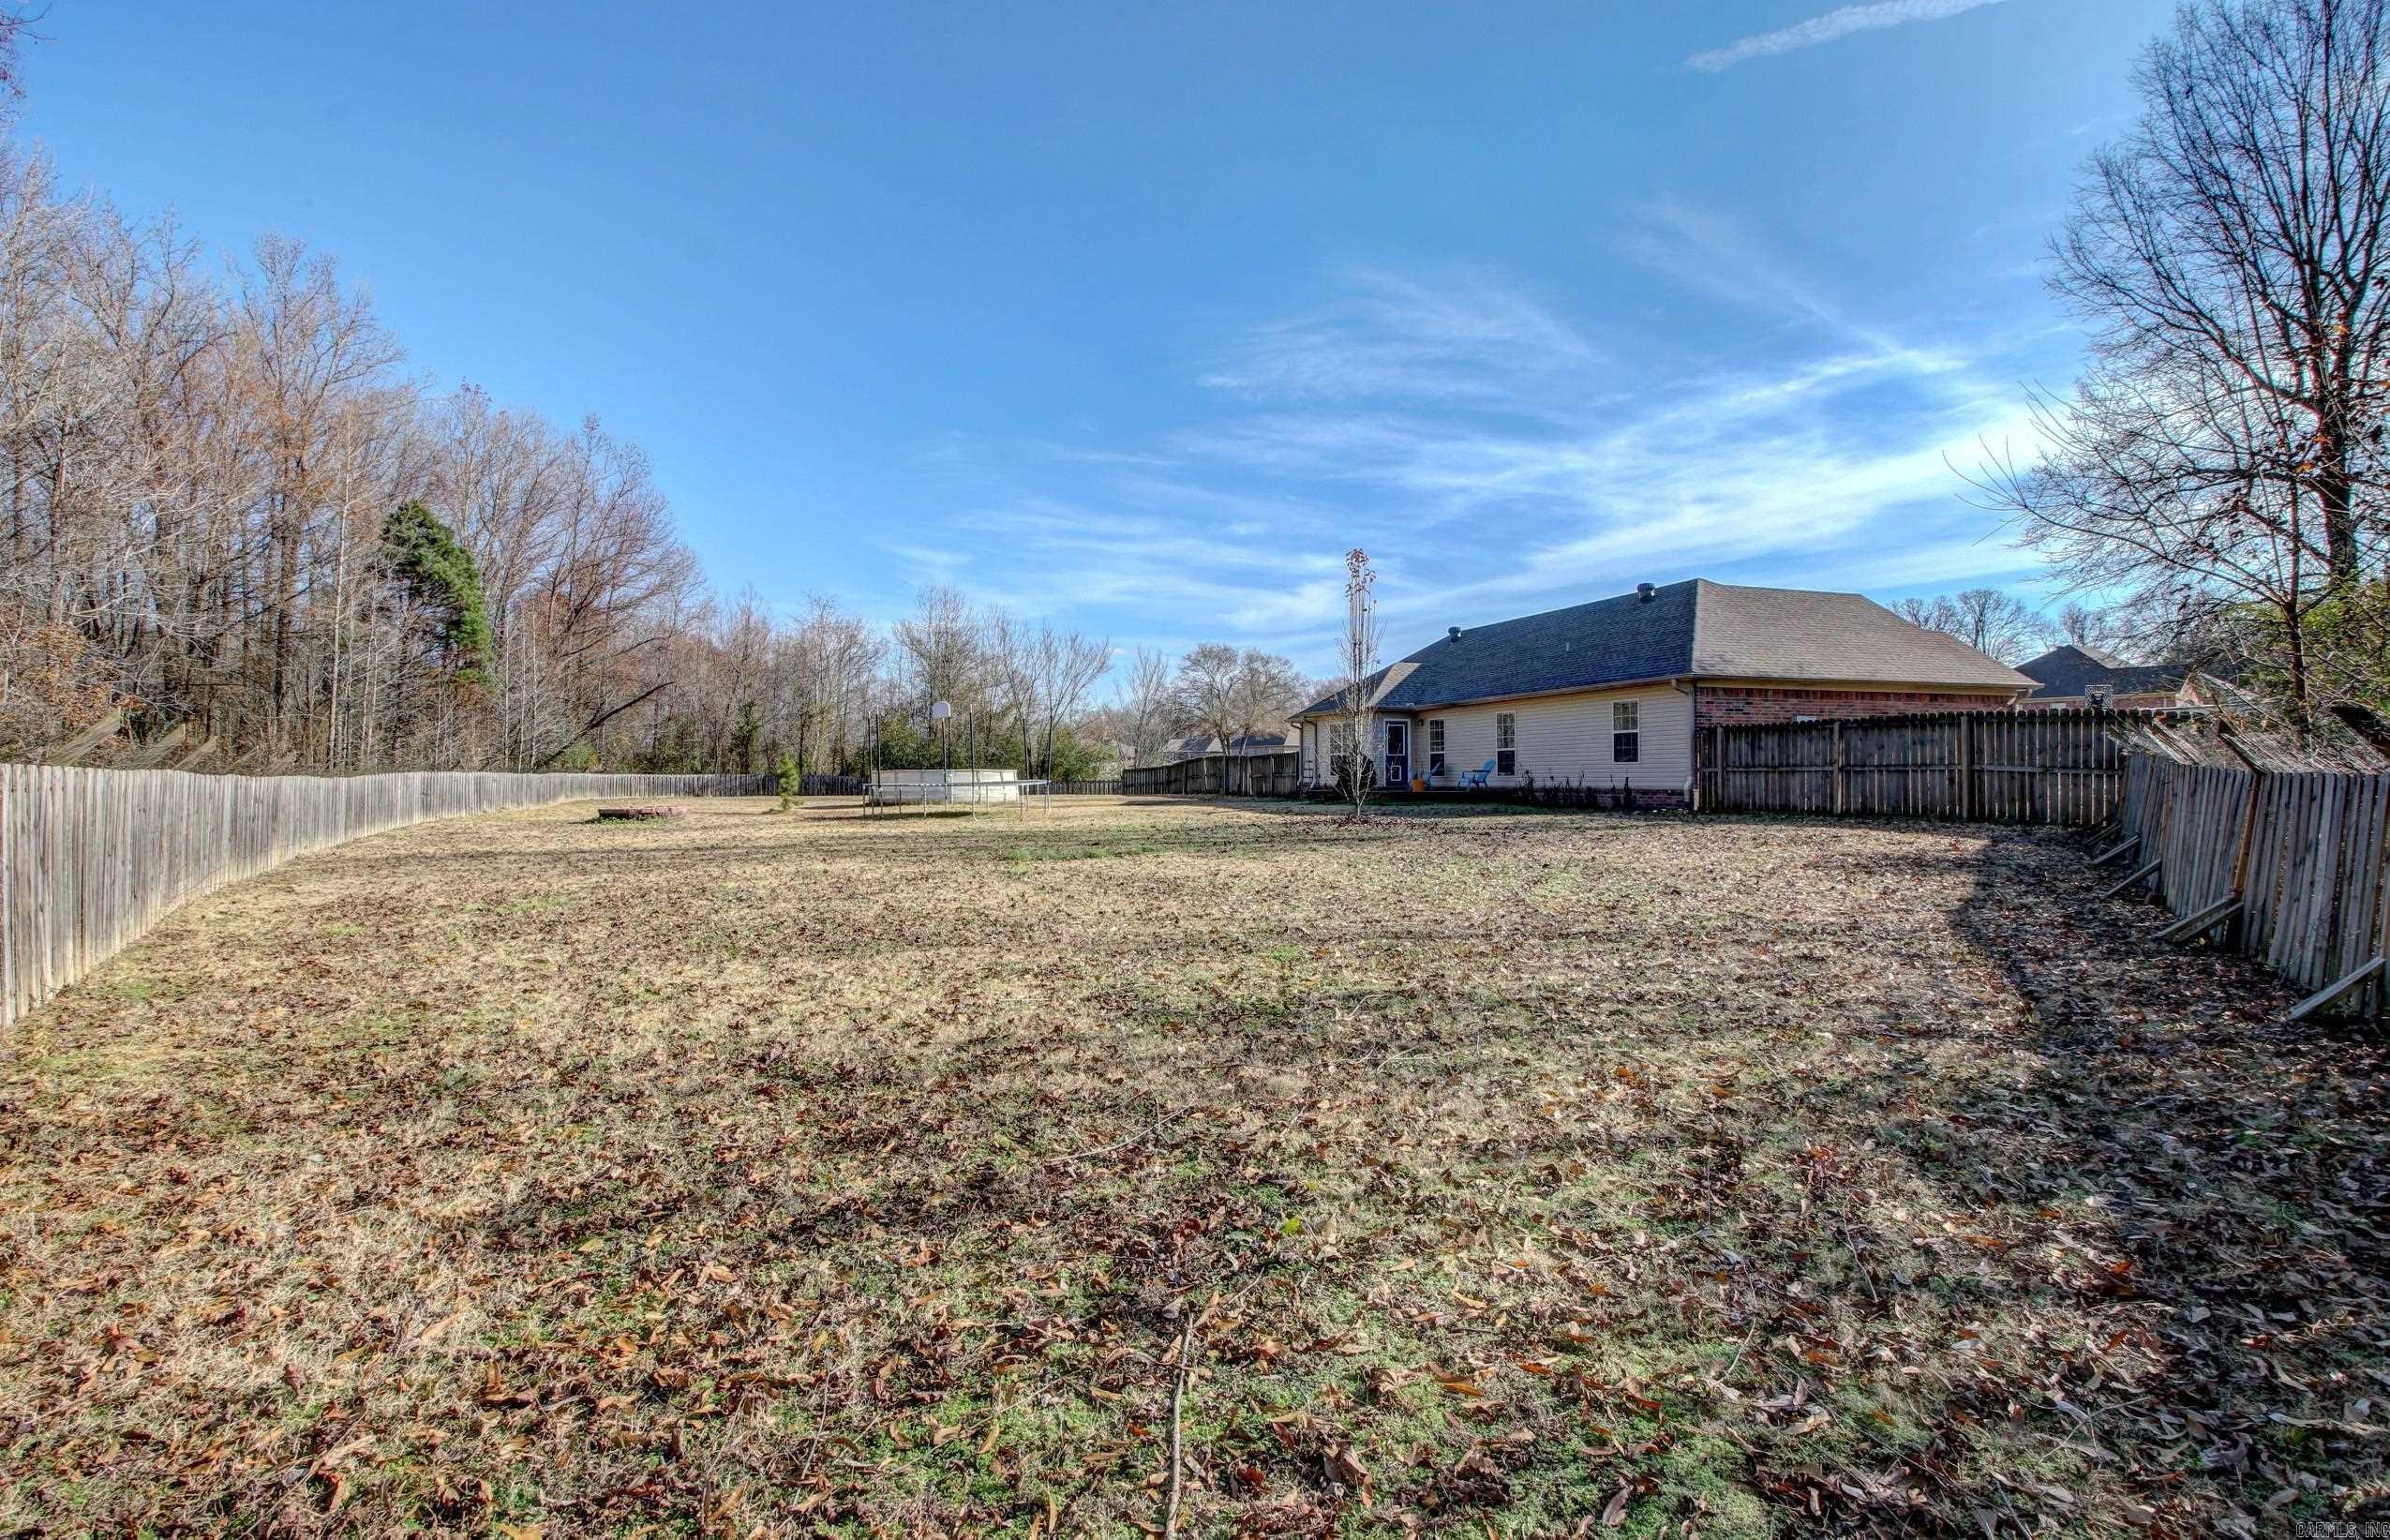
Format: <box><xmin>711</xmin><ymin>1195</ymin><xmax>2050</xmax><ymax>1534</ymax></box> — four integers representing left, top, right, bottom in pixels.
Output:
<box><xmin>24</xmin><ymin>0</ymin><xmax>2170</xmax><ymax>667</ymax></box>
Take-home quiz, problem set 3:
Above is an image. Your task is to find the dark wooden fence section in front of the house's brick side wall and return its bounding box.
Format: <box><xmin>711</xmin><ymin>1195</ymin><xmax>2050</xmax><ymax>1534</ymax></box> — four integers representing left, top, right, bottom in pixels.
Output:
<box><xmin>1699</xmin><ymin>710</ymin><xmax>2202</xmax><ymax>828</ymax></box>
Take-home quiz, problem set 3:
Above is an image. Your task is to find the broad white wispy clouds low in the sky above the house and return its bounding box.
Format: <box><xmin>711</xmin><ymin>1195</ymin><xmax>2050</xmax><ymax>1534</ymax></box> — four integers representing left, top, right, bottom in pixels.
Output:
<box><xmin>879</xmin><ymin>205</ymin><xmax>2034</xmax><ymax>667</ymax></box>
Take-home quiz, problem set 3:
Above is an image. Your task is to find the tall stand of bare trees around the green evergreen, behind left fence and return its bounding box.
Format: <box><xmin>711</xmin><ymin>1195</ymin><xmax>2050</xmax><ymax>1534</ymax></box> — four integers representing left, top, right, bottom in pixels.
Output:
<box><xmin>0</xmin><ymin>133</ymin><xmax>734</xmax><ymax>770</ymax></box>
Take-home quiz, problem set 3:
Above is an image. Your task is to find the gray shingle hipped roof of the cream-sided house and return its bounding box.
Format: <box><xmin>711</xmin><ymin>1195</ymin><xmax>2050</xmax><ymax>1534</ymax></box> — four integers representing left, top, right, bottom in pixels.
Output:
<box><xmin>1300</xmin><ymin>578</ymin><xmax>2034</xmax><ymax>715</ymax></box>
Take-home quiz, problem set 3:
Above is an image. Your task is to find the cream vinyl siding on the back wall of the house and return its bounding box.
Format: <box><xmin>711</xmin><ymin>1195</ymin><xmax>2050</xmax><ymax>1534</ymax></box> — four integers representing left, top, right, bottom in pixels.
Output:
<box><xmin>1412</xmin><ymin>684</ymin><xmax>1692</xmax><ymax>791</ymax></box>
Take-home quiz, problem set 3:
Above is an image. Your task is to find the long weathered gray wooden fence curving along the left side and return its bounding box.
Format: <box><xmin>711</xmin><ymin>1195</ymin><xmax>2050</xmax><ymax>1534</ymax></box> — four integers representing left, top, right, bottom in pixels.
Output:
<box><xmin>0</xmin><ymin>765</ymin><xmax>774</xmax><ymax>1028</ymax></box>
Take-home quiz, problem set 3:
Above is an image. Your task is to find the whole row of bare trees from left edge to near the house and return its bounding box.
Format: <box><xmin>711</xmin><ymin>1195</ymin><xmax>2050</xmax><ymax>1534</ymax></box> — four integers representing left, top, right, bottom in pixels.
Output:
<box><xmin>0</xmin><ymin>3</ymin><xmax>1348</xmax><ymax>777</ymax></box>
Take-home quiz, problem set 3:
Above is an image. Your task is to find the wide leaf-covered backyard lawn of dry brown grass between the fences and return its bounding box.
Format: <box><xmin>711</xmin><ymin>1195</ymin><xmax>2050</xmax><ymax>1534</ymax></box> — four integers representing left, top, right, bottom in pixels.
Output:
<box><xmin>0</xmin><ymin>799</ymin><xmax>2390</xmax><ymax>1540</ymax></box>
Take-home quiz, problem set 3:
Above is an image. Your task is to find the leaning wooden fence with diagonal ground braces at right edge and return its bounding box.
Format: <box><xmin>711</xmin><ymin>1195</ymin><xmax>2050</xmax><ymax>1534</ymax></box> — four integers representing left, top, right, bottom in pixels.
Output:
<box><xmin>2099</xmin><ymin>754</ymin><xmax>2390</xmax><ymax>1016</ymax></box>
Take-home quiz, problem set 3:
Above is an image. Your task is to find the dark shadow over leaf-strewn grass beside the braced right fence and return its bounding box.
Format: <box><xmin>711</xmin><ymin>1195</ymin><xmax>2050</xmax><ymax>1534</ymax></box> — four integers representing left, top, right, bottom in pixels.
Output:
<box><xmin>1806</xmin><ymin>825</ymin><xmax>2390</xmax><ymax>1535</ymax></box>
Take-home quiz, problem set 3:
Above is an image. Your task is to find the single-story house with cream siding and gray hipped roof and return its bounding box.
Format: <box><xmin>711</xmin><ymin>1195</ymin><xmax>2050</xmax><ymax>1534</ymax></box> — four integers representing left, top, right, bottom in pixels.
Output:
<box><xmin>1298</xmin><ymin>578</ymin><xmax>2034</xmax><ymax>801</ymax></box>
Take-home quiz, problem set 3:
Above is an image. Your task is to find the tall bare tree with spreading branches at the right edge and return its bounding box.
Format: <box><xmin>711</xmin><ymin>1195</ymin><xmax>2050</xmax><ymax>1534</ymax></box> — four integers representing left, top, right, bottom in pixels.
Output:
<box><xmin>1979</xmin><ymin>0</ymin><xmax>2390</xmax><ymax>722</ymax></box>
